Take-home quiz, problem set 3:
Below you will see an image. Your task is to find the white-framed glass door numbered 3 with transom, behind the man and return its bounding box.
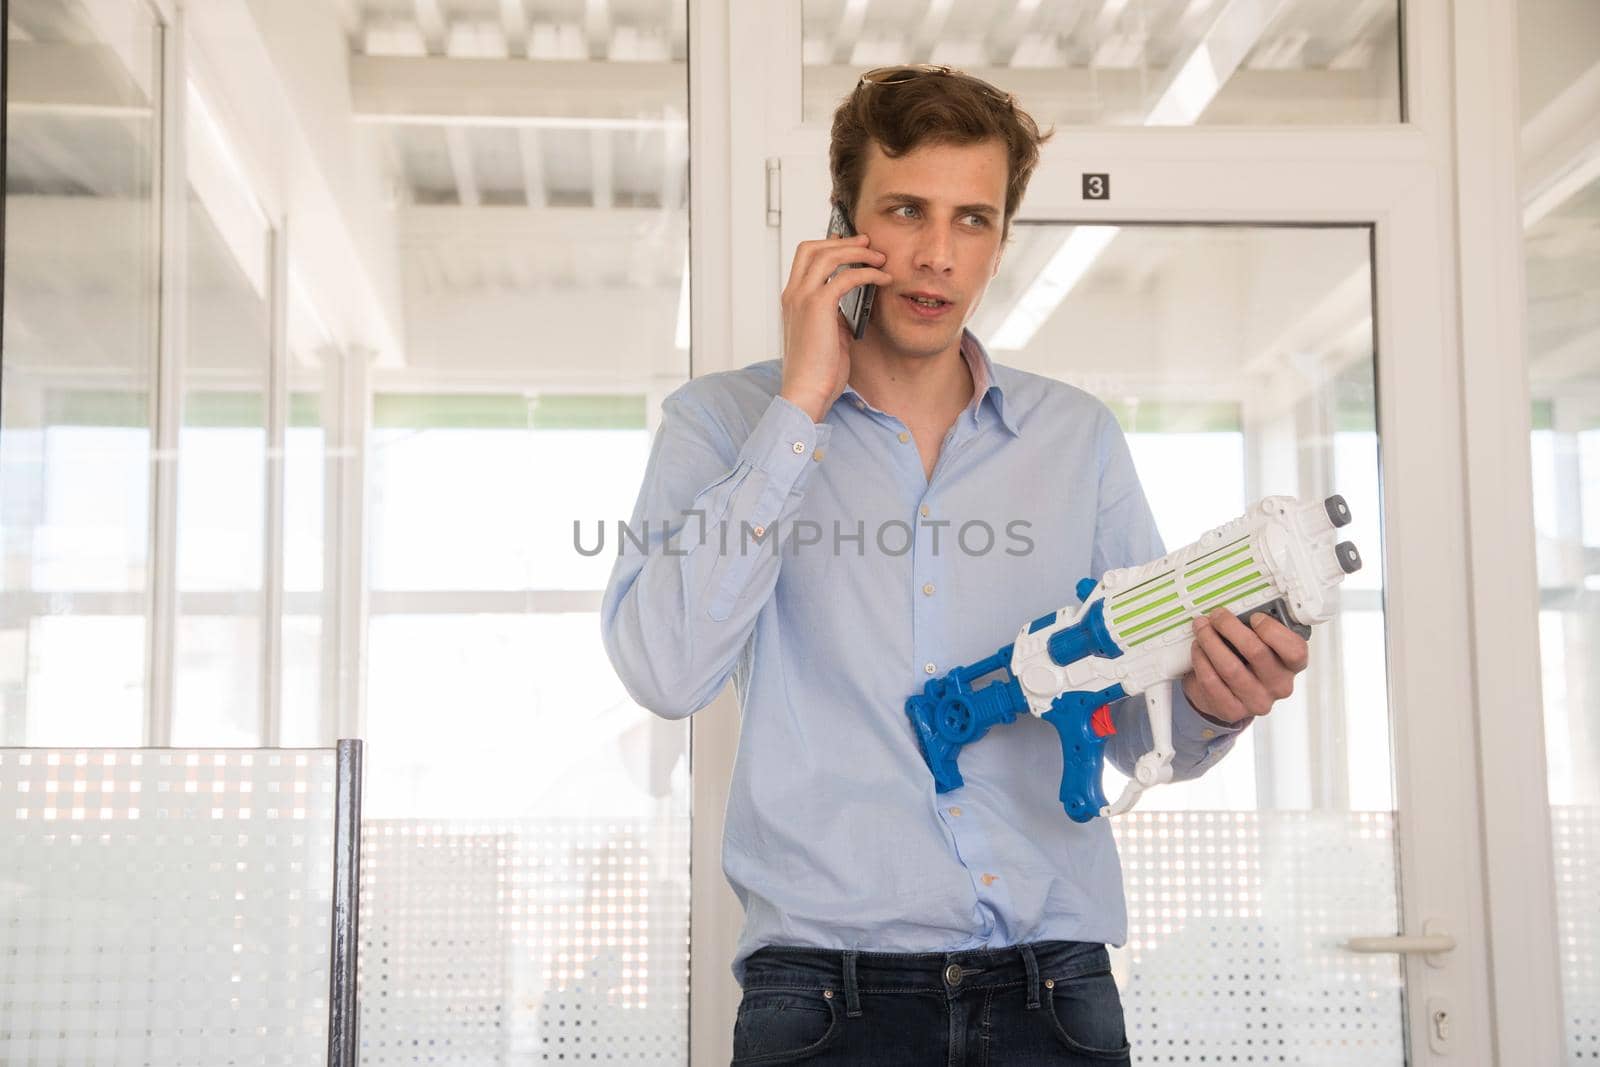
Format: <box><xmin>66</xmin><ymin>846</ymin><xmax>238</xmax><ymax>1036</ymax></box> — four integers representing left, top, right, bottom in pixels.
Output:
<box><xmin>734</xmin><ymin>0</ymin><xmax>1490</xmax><ymax>1064</ymax></box>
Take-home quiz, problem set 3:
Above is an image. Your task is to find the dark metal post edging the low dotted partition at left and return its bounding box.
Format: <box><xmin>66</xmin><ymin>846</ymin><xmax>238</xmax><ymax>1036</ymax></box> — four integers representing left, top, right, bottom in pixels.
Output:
<box><xmin>328</xmin><ymin>741</ymin><xmax>365</xmax><ymax>1067</ymax></box>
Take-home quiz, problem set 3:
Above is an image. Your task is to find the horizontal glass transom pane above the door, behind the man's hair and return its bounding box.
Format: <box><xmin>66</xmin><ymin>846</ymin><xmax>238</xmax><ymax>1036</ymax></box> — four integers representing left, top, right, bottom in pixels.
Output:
<box><xmin>803</xmin><ymin>0</ymin><xmax>1402</xmax><ymax>126</ymax></box>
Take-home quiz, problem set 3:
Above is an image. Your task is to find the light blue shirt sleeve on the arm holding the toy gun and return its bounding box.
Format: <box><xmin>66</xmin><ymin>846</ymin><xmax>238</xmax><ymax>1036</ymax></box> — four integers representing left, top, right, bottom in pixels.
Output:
<box><xmin>1090</xmin><ymin>410</ymin><xmax>1251</xmax><ymax>782</ymax></box>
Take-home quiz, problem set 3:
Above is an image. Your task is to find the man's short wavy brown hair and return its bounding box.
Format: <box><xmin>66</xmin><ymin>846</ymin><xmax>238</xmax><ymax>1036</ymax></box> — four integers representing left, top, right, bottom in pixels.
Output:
<box><xmin>827</xmin><ymin>67</ymin><xmax>1054</xmax><ymax>234</ymax></box>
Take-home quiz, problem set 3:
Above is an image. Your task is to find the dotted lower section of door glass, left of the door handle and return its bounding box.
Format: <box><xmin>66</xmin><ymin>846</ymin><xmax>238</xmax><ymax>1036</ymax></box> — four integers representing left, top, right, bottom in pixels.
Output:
<box><xmin>1112</xmin><ymin>811</ymin><xmax>1405</xmax><ymax>1067</ymax></box>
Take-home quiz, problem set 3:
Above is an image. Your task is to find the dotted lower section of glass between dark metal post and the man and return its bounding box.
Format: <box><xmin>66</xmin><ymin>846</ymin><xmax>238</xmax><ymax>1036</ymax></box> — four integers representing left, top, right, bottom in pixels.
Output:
<box><xmin>360</xmin><ymin>817</ymin><xmax>690</xmax><ymax>1067</ymax></box>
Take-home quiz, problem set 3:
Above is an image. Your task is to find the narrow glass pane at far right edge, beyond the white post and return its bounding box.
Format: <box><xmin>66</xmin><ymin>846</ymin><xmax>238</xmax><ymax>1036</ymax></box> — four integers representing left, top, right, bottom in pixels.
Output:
<box><xmin>1518</xmin><ymin>0</ymin><xmax>1600</xmax><ymax>1064</ymax></box>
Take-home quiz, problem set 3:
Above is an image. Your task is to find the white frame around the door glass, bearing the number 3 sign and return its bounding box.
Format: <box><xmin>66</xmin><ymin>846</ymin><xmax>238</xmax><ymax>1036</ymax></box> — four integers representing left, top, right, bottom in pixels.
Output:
<box><xmin>690</xmin><ymin>0</ymin><xmax>1563</xmax><ymax>1065</ymax></box>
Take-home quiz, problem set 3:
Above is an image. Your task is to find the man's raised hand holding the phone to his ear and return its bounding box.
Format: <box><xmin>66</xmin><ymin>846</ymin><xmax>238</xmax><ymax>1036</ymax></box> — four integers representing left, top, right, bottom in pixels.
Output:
<box><xmin>779</xmin><ymin>234</ymin><xmax>894</xmax><ymax>422</ymax></box>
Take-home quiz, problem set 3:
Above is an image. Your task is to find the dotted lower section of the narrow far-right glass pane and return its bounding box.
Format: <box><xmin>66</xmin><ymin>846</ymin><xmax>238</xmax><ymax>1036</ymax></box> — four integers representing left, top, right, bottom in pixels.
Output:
<box><xmin>1550</xmin><ymin>805</ymin><xmax>1600</xmax><ymax>1064</ymax></box>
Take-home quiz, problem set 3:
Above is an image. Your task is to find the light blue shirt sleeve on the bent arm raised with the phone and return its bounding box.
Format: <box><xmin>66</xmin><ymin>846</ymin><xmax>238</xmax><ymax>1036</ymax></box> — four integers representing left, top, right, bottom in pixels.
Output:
<box><xmin>600</xmin><ymin>389</ymin><xmax>832</xmax><ymax>718</ymax></box>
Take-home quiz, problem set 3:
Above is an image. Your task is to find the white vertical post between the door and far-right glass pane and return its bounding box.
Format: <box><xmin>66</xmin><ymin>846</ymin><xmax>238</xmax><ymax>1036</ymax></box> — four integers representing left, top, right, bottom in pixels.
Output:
<box><xmin>1446</xmin><ymin>0</ymin><xmax>1568</xmax><ymax>1065</ymax></box>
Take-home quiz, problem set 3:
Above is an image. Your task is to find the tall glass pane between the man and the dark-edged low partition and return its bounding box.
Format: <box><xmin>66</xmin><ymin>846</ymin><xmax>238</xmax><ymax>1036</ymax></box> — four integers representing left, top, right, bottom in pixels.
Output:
<box><xmin>352</xmin><ymin>0</ymin><xmax>690</xmax><ymax>1064</ymax></box>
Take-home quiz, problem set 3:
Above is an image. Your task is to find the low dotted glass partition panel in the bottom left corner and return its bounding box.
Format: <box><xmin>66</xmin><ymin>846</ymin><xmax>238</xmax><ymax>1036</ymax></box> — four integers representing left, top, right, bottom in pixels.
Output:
<box><xmin>0</xmin><ymin>749</ymin><xmax>334</xmax><ymax>1067</ymax></box>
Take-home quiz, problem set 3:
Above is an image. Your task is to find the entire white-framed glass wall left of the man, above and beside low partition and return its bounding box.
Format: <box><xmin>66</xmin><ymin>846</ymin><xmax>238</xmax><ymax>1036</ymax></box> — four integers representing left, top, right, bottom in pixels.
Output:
<box><xmin>0</xmin><ymin>0</ymin><xmax>690</xmax><ymax>1064</ymax></box>
